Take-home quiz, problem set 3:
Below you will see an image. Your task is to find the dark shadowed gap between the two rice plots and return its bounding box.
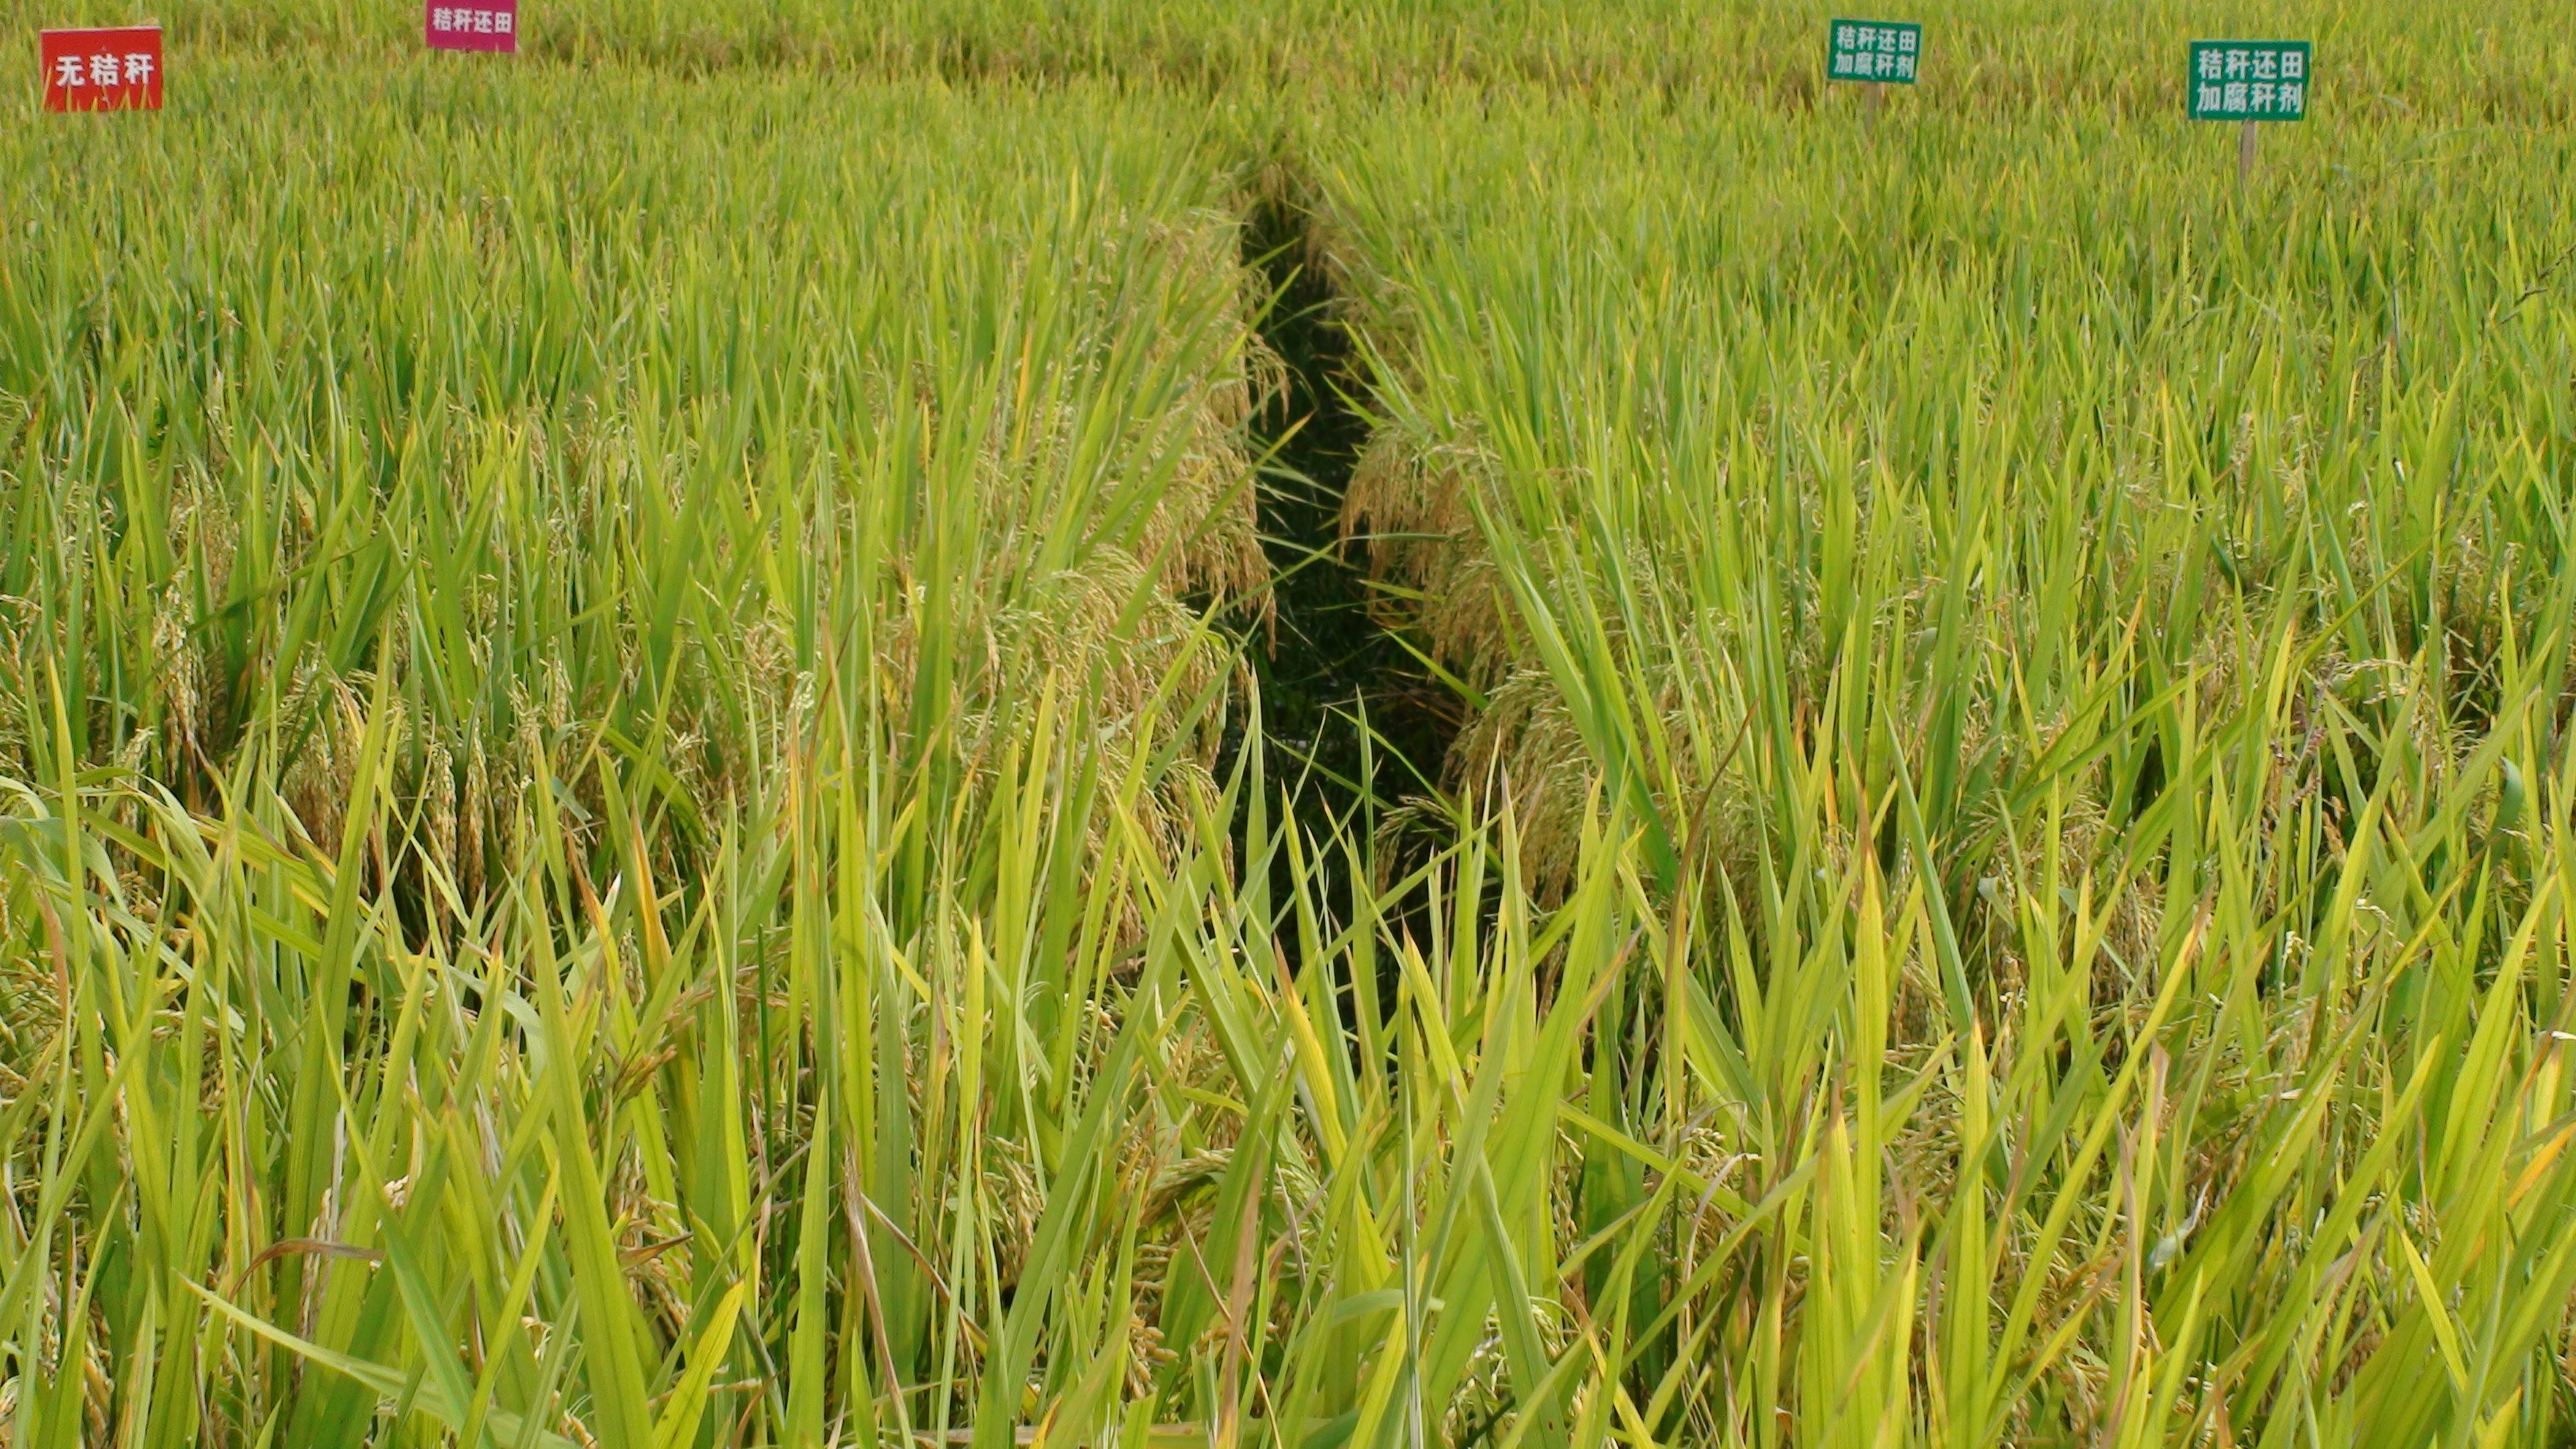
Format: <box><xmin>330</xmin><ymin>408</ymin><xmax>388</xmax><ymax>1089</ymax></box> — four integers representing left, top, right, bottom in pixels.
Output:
<box><xmin>1244</xmin><ymin>178</ymin><xmax>1460</xmax><ymax>962</ymax></box>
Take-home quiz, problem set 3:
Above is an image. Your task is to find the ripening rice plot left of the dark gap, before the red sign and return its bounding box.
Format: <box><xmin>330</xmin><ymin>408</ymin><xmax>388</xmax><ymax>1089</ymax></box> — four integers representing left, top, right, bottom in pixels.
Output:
<box><xmin>0</xmin><ymin>50</ymin><xmax>1288</xmax><ymax>1444</ymax></box>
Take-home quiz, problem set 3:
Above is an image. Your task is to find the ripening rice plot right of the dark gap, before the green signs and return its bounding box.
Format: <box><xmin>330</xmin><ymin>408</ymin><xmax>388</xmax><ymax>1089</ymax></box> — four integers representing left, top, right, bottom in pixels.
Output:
<box><xmin>1316</xmin><ymin>25</ymin><xmax>2576</xmax><ymax>1444</ymax></box>
